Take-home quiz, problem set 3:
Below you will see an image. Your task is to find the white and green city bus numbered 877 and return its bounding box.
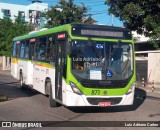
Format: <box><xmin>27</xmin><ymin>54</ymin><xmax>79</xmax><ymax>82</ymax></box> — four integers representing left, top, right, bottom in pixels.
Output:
<box><xmin>11</xmin><ymin>24</ymin><xmax>136</xmax><ymax>107</ymax></box>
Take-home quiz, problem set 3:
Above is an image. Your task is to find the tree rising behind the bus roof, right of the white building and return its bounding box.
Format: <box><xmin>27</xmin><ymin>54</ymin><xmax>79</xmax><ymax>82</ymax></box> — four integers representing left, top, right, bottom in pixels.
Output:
<box><xmin>46</xmin><ymin>0</ymin><xmax>95</xmax><ymax>27</ymax></box>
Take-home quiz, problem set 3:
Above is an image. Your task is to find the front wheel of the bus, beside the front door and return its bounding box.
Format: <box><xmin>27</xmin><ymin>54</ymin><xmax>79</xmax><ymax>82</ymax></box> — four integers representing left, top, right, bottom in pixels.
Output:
<box><xmin>46</xmin><ymin>81</ymin><xmax>59</xmax><ymax>107</ymax></box>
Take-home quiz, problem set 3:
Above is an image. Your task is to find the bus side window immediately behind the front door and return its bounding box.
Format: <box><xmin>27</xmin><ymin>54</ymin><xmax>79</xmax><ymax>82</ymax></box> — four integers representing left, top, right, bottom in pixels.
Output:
<box><xmin>46</xmin><ymin>38</ymin><xmax>55</xmax><ymax>62</ymax></box>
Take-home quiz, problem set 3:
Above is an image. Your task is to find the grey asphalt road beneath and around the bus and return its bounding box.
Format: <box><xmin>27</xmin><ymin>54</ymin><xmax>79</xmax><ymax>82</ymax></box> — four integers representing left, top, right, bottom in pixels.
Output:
<box><xmin>0</xmin><ymin>72</ymin><xmax>160</xmax><ymax>130</ymax></box>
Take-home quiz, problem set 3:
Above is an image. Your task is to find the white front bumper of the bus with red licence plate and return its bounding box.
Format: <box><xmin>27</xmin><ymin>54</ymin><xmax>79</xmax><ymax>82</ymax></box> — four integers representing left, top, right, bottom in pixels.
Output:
<box><xmin>63</xmin><ymin>91</ymin><xmax>134</xmax><ymax>107</ymax></box>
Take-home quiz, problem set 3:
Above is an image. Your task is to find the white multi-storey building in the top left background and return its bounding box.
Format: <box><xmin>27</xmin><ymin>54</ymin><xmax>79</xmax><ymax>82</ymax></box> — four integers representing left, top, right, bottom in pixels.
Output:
<box><xmin>0</xmin><ymin>0</ymin><xmax>48</xmax><ymax>29</ymax></box>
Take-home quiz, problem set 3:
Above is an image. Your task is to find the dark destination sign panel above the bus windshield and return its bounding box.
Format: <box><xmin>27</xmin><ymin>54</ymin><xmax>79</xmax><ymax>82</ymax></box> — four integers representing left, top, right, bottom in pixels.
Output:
<box><xmin>72</xmin><ymin>25</ymin><xmax>132</xmax><ymax>40</ymax></box>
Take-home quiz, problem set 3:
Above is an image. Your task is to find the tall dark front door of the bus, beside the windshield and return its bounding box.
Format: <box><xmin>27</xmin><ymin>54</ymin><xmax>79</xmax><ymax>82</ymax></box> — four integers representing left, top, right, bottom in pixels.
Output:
<box><xmin>55</xmin><ymin>34</ymin><xmax>66</xmax><ymax>100</ymax></box>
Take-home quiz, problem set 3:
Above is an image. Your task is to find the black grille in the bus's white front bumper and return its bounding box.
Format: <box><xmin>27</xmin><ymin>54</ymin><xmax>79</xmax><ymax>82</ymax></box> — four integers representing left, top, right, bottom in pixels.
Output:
<box><xmin>87</xmin><ymin>97</ymin><xmax>122</xmax><ymax>105</ymax></box>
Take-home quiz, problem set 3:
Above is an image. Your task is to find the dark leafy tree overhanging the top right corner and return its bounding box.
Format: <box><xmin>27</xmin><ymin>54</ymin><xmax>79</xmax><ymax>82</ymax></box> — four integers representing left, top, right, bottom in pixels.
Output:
<box><xmin>105</xmin><ymin>0</ymin><xmax>160</xmax><ymax>39</ymax></box>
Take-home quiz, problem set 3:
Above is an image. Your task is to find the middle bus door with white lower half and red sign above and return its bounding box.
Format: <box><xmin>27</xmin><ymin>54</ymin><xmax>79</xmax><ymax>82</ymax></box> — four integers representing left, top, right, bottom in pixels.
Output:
<box><xmin>28</xmin><ymin>38</ymin><xmax>36</xmax><ymax>85</ymax></box>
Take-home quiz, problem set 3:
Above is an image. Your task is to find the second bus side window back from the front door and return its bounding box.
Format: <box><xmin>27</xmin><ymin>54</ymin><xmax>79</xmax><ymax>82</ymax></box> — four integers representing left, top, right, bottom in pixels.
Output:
<box><xmin>37</xmin><ymin>37</ymin><xmax>47</xmax><ymax>60</ymax></box>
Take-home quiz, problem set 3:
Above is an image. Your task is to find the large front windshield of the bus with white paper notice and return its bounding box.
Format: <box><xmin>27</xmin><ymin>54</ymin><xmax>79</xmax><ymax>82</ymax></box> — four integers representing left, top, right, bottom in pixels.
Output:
<box><xmin>71</xmin><ymin>40</ymin><xmax>134</xmax><ymax>80</ymax></box>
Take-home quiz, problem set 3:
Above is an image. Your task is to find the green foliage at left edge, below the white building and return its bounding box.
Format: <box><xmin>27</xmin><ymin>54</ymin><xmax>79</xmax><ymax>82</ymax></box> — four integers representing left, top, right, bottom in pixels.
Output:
<box><xmin>0</xmin><ymin>16</ymin><xmax>31</xmax><ymax>56</ymax></box>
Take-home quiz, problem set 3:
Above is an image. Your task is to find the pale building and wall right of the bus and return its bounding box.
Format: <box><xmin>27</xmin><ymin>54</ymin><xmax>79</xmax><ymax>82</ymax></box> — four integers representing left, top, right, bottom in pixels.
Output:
<box><xmin>132</xmin><ymin>32</ymin><xmax>160</xmax><ymax>91</ymax></box>
